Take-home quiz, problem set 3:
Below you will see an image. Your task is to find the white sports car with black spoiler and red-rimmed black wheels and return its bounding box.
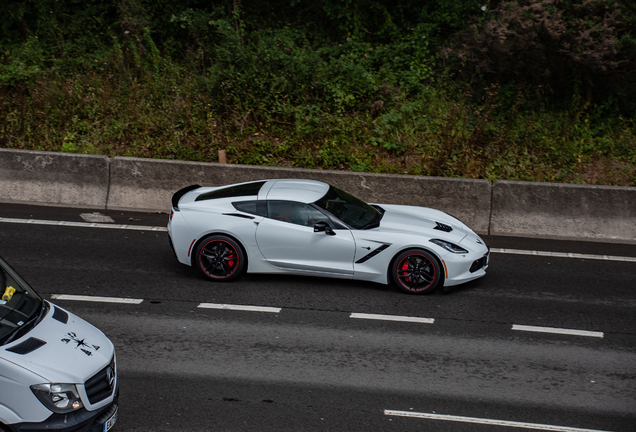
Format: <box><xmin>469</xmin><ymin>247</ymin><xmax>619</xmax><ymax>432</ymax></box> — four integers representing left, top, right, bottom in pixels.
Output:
<box><xmin>168</xmin><ymin>179</ymin><xmax>489</xmax><ymax>294</ymax></box>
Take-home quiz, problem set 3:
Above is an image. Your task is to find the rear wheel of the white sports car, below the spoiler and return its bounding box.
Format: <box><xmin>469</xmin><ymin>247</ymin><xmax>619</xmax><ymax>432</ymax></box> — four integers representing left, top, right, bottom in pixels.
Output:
<box><xmin>194</xmin><ymin>235</ymin><xmax>245</xmax><ymax>282</ymax></box>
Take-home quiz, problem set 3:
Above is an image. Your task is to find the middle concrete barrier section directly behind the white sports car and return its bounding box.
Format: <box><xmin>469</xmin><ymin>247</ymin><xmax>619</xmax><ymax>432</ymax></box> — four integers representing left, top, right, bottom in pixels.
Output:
<box><xmin>107</xmin><ymin>157</ymin><xmax>492</xmax><ymax>234</ymax></box>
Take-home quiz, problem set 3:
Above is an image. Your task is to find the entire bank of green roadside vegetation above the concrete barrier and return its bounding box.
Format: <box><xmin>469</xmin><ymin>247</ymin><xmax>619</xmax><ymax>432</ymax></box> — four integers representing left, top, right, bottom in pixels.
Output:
<box><xmin>0</xmin><ymin>0</ymin><xmax>636</xmax><ymax>186</ymax></box>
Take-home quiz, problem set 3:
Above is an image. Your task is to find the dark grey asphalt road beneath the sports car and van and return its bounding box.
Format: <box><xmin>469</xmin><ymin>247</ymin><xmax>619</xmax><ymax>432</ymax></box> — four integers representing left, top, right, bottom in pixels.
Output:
<box><xmin>0</xmin><ymin>204</ymin><xmax>636</xmax><ymax>432</ymax></box>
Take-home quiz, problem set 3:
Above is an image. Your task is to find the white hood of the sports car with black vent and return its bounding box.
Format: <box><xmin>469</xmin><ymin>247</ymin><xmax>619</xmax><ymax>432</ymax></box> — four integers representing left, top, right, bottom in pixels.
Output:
<box><xmin>379</xmin><ymin>204</ymin><xmax>470</xmax><ymax>243</ymax></box>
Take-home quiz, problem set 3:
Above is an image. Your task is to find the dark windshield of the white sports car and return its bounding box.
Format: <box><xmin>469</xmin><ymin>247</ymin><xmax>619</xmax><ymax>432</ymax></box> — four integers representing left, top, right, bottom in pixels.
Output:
<box><xmin>315</xmin><ymin>186</ymin><xmax>382</xmax><ymax>229</ymax></box>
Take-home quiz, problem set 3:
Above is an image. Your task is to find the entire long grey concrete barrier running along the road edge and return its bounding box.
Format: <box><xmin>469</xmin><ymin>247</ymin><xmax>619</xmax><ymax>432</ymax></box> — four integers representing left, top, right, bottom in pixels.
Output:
<box><xmin>0</xmin><ymin>148</ymin><xmax>636</xmax><ymax>243</ymax></box>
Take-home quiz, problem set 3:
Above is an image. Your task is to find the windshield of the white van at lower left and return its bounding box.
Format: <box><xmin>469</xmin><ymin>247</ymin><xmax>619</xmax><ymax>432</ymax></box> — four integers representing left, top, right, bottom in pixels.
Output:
<box><xmin>0</xmin><ymin>258</ymin><xmax>43</xmax><ymax>345</ymax></box>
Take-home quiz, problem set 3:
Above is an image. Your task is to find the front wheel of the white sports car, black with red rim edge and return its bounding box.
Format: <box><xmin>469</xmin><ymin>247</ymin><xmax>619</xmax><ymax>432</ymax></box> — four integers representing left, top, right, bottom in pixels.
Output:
<box><xmin>391</xmin><ymin>249</ymin><xmax>442</xmax><ymax>294</ymax></box>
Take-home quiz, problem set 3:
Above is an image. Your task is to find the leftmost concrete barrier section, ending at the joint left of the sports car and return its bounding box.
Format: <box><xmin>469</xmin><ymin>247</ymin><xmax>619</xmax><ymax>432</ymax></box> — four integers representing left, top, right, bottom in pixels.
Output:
<box><xmin>0</xmin><ymin>148</ymin><xmax>110</xmax><ymax>209</ymax></box>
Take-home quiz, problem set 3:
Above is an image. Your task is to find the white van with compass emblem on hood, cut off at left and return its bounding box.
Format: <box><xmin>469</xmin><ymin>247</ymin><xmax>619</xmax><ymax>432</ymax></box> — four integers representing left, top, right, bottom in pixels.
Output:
<box><xmin>0</xmin><ymin>258</ymin><xmax>119</xmax><ymax>432</ymax></box>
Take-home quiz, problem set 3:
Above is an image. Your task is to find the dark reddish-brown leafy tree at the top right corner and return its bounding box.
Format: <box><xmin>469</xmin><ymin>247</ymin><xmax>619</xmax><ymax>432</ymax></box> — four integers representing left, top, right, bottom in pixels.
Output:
<box><xmin>442</xmin><ymin>0</ymin><xmax>636</xmax><ymax>112</ymax></box>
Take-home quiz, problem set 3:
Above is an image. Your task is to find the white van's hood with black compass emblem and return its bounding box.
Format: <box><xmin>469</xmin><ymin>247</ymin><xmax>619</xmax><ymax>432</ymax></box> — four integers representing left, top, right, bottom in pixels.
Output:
<box><xmin>0</xmin><ymin>304</ymin><xmax>114</xmax><ymax>383</ymax></box>
